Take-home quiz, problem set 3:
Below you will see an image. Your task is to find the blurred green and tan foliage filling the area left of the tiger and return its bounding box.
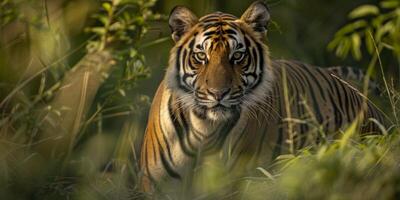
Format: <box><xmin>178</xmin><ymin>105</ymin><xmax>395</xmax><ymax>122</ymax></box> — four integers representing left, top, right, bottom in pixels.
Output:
<box><xmin>0</xmin><ymin>0</ymin><xmax>161</xmax><ymax>199</ymax></box>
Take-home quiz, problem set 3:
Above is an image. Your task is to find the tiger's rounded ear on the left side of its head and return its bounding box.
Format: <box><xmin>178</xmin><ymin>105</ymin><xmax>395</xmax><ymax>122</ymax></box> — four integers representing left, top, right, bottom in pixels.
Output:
<box><xmin>168</xmin><ymin>6</ymin><xmax>198</xmax><ymax>42</ymax></box>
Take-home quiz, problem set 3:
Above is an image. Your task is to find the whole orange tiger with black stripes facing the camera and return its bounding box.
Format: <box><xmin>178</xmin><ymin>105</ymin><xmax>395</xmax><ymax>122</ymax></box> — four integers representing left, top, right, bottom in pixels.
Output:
<box><xmin>140</xmin><ymin>1</ymin><xmax>385</xmax><ymax>195</ymax></box>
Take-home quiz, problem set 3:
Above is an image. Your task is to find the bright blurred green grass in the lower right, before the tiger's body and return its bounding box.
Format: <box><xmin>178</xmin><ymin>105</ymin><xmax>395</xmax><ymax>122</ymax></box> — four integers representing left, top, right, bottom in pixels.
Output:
<box><xmin>241</xmin><ymin>131</ymin><xmax>400</xmax><ymax>199</ymax></box>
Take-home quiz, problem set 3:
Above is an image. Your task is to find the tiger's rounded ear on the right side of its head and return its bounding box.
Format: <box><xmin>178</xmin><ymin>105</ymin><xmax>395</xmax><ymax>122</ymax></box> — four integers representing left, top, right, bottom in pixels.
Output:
<box><xmin>240</xmin><ymin>1</ymin><xmax>270</xmax><ymax>34</ymax></box>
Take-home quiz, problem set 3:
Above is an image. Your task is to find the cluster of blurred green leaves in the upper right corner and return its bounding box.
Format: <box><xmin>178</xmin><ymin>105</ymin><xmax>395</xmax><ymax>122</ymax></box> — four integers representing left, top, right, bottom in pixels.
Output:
<box><xmin>328</xmin><ymin>0</ymin><xmax>400</xmax><ymax>65</ymax></box>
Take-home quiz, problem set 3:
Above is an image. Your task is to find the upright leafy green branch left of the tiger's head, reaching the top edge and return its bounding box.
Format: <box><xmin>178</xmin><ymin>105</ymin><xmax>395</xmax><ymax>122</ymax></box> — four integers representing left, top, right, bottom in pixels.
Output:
<box><xmin>86</xmin><ymin>0</ymin><xmax>162</xmax><ymax>104</ymax></box>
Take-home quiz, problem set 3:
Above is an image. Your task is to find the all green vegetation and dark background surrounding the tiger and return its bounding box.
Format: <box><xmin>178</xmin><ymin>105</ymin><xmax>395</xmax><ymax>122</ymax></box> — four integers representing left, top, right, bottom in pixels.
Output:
<box><xmin>0</xmin><ymin>0</ymin><xmax>400</xmax><ymax>199</ymax></box>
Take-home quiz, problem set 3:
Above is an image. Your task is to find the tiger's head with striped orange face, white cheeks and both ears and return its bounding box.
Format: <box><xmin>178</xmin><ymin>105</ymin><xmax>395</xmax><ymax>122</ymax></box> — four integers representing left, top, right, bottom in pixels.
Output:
<box><xmin>166</xmin><ymin>2</ymin><xmax>273</xmax><ymax>121</ymax></box>
